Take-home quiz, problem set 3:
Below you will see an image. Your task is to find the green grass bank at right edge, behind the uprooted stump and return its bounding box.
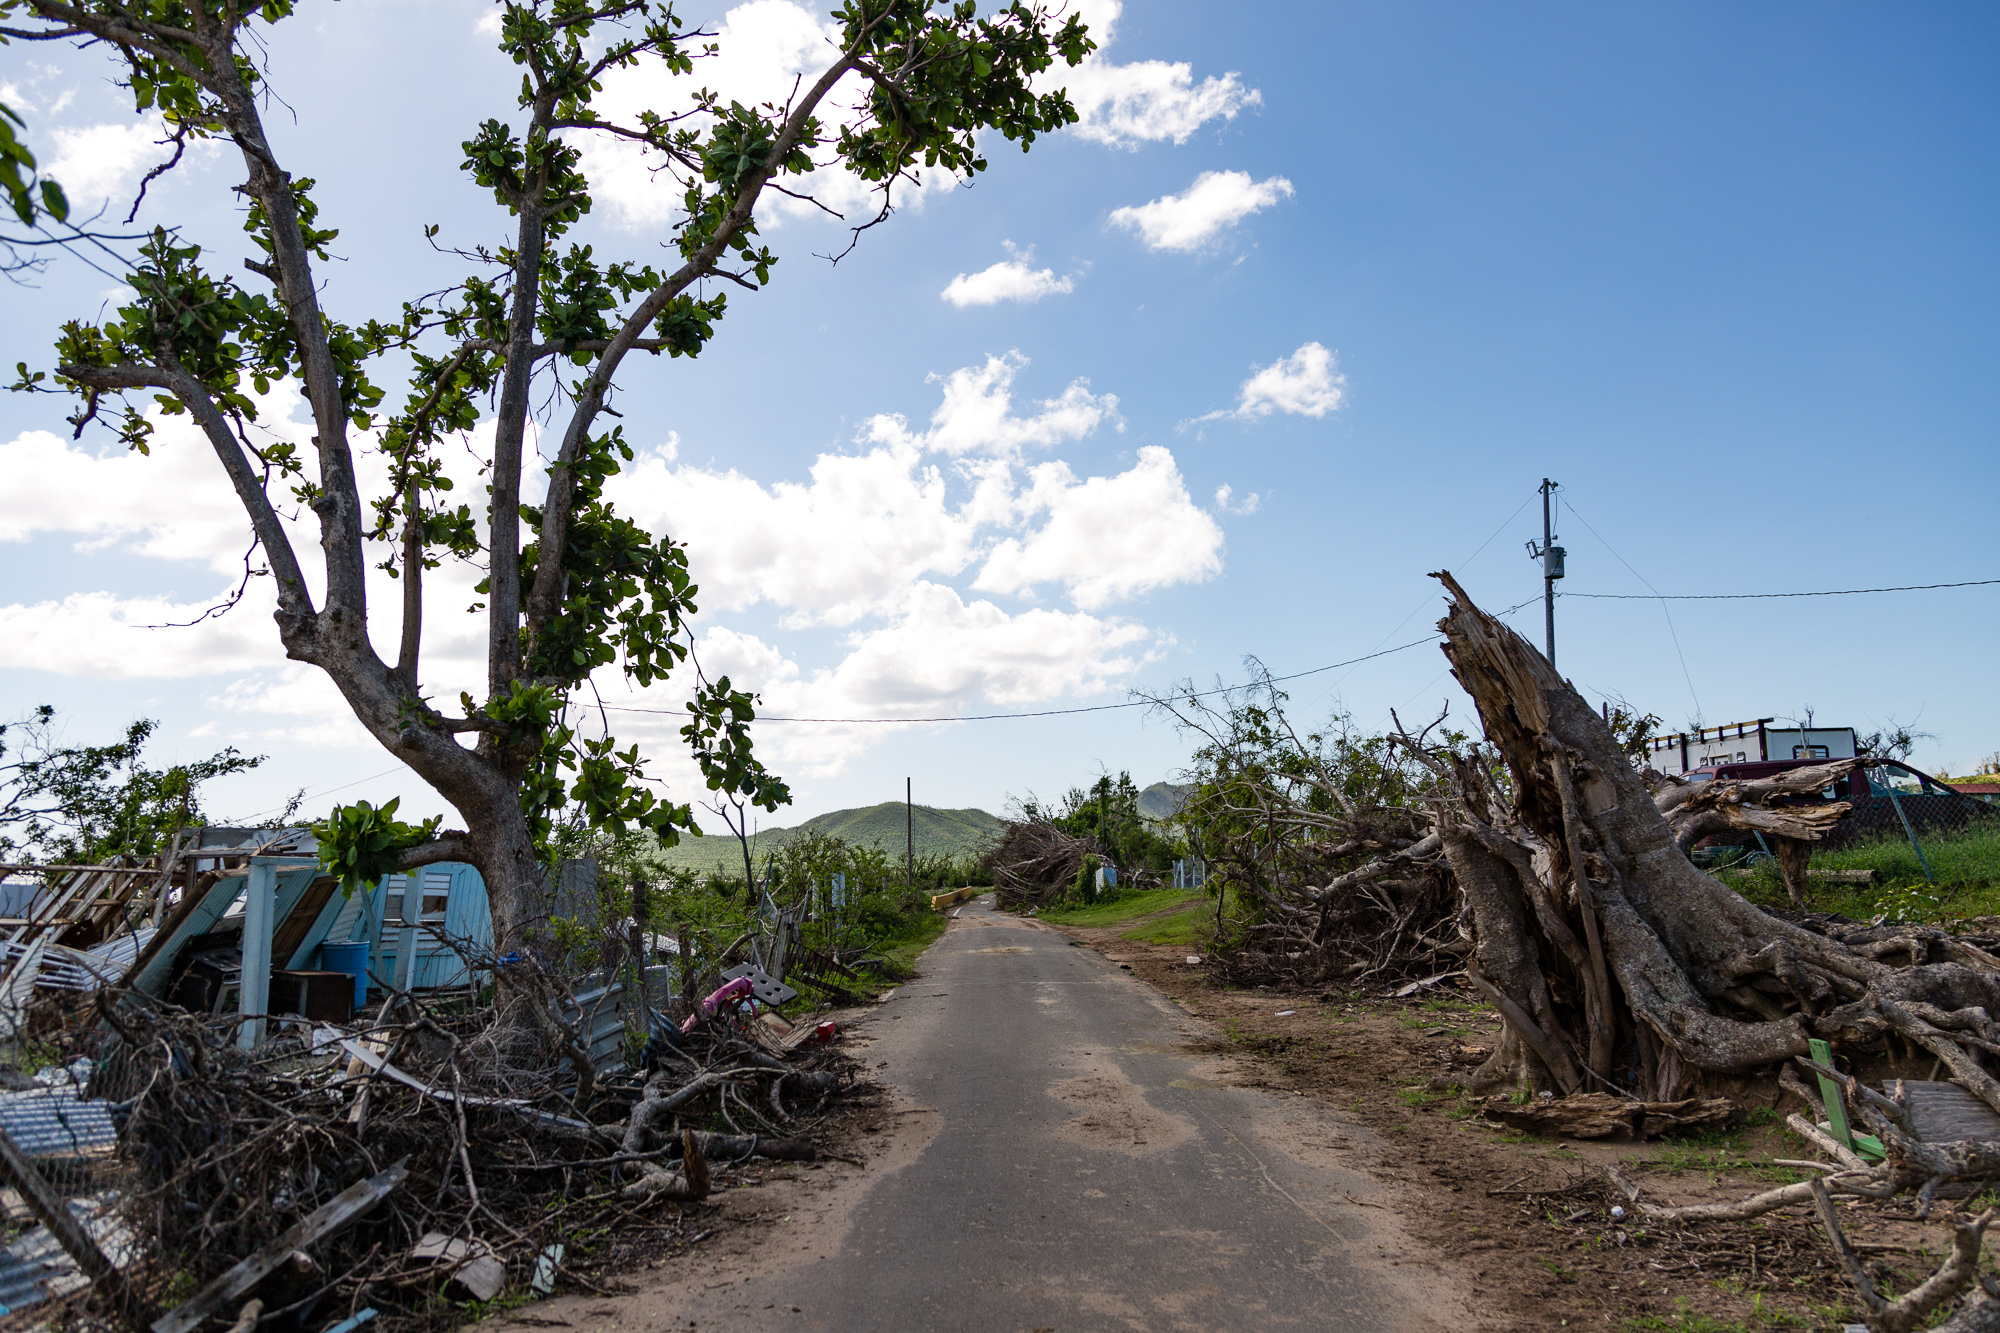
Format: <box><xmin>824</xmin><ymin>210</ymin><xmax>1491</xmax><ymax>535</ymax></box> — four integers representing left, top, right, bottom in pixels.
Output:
<box><xmin>1722</xmin><ymin>821</ymin><xmax>2000</xmax><ymax>921</ymax></box>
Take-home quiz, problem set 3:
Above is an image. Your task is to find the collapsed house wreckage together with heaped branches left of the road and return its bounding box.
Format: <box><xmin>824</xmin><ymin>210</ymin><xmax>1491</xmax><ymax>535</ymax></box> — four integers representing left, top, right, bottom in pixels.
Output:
<box><xmin>0</xmin><ymin>841</ymin><xmax>854</xmax><ymax>1333</ymax></box>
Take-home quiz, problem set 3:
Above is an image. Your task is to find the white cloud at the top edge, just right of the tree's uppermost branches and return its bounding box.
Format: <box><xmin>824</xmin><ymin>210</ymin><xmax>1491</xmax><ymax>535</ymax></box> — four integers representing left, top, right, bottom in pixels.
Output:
<box><xmin>1036</xmin><ymin>0</ymin><xmax>1264</xmax><ymax>148</ymax></box>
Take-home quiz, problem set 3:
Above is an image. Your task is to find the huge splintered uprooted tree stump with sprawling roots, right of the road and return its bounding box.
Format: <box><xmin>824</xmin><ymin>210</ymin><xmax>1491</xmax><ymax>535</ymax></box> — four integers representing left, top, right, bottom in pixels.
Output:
<box><xmin>1436</xmin><ymin>574</ymin><xmax>2000</xmax><ymax>1109</ymax></box>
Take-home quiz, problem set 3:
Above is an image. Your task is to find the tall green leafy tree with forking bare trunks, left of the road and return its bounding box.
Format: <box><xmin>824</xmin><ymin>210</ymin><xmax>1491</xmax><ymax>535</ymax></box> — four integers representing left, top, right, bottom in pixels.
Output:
<box><xmin>0</xmin><ymin>0</ymin><xmax>1092</xmax><ymax>985</ymax></box>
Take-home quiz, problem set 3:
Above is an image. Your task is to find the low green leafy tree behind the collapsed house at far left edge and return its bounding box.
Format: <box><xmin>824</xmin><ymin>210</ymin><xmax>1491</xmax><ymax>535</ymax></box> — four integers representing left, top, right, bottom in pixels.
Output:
<box><xmin>0</xmin><ymin>705</ymin><xmax>282</xmax><ymax>865</ymax></box>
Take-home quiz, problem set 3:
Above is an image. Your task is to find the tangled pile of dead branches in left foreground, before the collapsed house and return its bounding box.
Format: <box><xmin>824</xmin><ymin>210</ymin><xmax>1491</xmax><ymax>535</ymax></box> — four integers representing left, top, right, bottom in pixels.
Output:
<box><xmin>0</xmin><ymin>975</ymin><xmax>852</xmax><ymax>1333</ymax></box>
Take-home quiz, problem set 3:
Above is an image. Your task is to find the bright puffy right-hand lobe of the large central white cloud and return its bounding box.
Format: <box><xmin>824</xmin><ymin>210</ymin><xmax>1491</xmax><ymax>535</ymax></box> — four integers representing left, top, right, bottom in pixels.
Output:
<box><xmin>972</xmin><ymin>444</ymin><xmax>1222</xmax><ymax>610</ymax></box>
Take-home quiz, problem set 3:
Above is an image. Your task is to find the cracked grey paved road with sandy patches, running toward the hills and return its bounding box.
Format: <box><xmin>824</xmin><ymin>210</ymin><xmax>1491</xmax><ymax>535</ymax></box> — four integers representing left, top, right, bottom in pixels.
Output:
<box><xmin>540</xmin><ymin>899</ymin><xmax>1470</xmax><ymax>1333</ymax></box>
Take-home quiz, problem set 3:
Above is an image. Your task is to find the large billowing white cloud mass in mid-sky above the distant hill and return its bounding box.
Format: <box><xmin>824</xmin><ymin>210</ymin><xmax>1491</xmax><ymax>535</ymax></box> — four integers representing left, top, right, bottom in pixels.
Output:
<box><xmin>606</xmin><ymin>352</ymin><xmax>1184</xmax><ymax>624</ymax></box>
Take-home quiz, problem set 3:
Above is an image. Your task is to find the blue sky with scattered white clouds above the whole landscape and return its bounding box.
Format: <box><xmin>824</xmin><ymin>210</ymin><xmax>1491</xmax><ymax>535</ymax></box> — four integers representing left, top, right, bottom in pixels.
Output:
<box><xmin>0</xmin><ymin>0</ymin><xmax>2000</xmax><ymax>823</ymax></box>
